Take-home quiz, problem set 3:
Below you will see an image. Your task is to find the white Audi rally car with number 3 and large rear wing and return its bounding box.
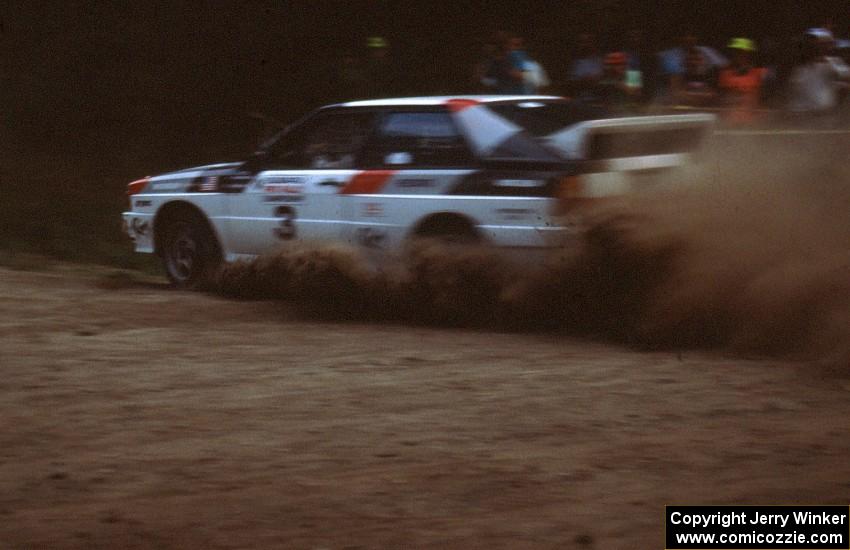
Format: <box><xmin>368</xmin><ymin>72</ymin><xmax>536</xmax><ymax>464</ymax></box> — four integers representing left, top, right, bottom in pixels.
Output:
<box><xmin>123</xmin><ymin>96</ymin><xmax>713</xmax><ymax>287</ymax></box>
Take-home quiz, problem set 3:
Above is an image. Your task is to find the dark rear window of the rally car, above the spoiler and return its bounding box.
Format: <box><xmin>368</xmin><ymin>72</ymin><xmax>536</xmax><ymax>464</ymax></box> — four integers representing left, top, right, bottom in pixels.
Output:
<box><xmin>480</xmin><ymin>100</ymin><xmax>605</xmax><ymax>137</ymax></box>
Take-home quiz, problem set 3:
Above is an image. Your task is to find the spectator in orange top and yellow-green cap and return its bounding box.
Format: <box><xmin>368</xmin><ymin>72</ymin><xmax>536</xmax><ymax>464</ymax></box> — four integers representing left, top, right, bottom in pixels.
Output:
<box><xmin>718</xmin><ymin>38</ymin><xmax>767</xmax><ymax>122</ymax></box>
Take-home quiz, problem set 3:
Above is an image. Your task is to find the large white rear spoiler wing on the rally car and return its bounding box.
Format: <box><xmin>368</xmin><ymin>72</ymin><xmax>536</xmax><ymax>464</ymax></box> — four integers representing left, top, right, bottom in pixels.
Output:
<box><xmin>544</xmin><ymin>114</ymin><xmax>716</xmax><ymax>173</ymax></box>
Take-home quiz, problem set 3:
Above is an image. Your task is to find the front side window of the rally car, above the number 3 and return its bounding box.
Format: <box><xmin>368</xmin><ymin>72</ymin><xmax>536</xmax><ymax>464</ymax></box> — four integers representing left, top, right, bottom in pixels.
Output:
<box><xmin>268</xmin><ymin>113</ymin><xmax>374</xmax><ymax>169</ymax></box>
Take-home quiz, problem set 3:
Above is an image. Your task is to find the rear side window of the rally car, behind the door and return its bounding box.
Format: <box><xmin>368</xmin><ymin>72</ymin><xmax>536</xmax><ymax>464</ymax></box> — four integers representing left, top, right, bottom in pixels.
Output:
<box><xmin>365</xmin><ymin>112</ymin><xmax>472</xmax><ymax>168</ymax></box>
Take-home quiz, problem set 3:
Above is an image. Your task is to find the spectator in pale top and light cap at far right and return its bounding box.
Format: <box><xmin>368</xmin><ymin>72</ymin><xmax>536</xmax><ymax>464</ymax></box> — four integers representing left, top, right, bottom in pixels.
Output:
<box><xmin>788</xmin><ymin>28</ymin><xmax>850</xmax><ymax>114</ymax></box>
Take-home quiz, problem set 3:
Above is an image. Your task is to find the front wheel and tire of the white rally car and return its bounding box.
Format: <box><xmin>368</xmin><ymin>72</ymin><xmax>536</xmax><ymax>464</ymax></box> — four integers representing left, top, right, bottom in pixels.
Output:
<box><xmin>160</xmin><ymin>215</ymin><xmax>221</xmax><ymax>289</ymax></box>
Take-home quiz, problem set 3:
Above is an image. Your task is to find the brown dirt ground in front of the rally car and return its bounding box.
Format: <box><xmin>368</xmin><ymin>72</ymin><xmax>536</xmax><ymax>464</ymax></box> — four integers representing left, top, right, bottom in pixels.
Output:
<box><xmin>0</xmin><ymin>269</ymin><xmax>850</xmax><ymax>549</ymax></box>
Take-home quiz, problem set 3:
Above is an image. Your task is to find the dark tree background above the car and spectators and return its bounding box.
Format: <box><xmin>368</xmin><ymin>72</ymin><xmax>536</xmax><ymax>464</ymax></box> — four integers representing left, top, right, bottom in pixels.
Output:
<box><xmin>0</xmin><ymin>0</ymin><xmax>850</xmax><ymax>172</ymax></box>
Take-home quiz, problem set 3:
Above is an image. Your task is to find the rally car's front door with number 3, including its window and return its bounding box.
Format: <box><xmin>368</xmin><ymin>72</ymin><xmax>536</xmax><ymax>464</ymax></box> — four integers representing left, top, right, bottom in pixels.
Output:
<box><xmin>228</xmin><ymin>110</ymin><xmax>373</xmax><ymax>255</ymax></box>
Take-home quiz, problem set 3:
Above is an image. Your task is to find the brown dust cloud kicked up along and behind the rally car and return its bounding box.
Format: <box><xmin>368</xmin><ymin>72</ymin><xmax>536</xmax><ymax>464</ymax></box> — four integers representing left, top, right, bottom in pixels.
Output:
<box><xmin>212</xmin><ymin>136</ymin><xmax>850</xmax><ymax>360</ymax></box>
